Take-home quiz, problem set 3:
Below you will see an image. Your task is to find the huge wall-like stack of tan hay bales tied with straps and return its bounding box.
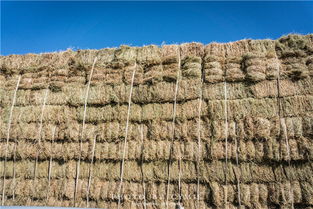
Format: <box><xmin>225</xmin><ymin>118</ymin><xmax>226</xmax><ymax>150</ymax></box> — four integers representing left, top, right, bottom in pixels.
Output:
<box><xmin>0</xmin><ymin>35</ymin><xmax>313</xmax><ymax>208</ymax></box>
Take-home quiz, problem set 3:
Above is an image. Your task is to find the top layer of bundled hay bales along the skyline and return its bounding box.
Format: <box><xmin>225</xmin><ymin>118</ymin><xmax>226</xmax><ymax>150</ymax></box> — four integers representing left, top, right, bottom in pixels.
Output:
<box><xmin>0</xmin><ymin>34</ymin><xmax>313</xmax><ymax>83</ymax></box>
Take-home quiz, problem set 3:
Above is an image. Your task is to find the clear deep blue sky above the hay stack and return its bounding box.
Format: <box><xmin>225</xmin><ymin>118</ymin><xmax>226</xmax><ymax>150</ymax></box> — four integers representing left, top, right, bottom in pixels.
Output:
<box><xmin>1</xmin><ymin>1</ymin><xmax>313</xmax><ymax>55</ymax></box>
